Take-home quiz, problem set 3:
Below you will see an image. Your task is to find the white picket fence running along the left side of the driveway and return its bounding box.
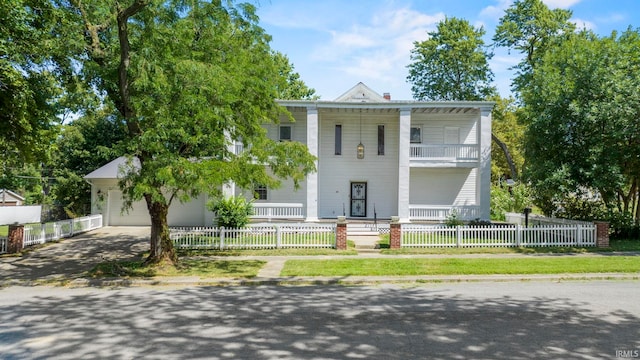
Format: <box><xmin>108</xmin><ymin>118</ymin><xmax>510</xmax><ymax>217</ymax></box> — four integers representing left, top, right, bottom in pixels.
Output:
<box><xmin>0</xmin><ymin>215</ymin><xmax>102</xmax><ymax>253</ymax></box>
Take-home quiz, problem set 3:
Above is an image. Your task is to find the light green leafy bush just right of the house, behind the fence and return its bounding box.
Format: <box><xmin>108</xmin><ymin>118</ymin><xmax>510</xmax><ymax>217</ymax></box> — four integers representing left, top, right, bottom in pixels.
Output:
<box><xmin>491</xmin><ymin>183</ymin><xmax>533</xmax><ymax>221</ymax></box>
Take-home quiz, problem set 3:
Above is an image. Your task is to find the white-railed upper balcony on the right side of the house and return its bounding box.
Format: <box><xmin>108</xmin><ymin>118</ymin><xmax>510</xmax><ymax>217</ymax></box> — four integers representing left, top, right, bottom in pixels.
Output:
<box><xmin>409</xmin><ymin>144</ymin><xmax>480</xmax><ymax>167</ymax></box>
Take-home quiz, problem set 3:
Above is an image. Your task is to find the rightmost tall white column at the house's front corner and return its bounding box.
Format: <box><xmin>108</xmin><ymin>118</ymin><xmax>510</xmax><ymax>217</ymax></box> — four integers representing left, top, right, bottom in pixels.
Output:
<box><xmin>476</xmin><ymin>107</ymin><xmax>492</xmax><ymax>220</ymax></box>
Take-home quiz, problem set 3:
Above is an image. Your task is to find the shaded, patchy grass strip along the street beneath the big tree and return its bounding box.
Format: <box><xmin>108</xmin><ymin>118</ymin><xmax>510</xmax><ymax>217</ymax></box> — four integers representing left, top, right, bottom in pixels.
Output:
<box><xmin>88</xmin><ymin>260</ymin><xmax>266</xmax><ymax>278</ymax></box>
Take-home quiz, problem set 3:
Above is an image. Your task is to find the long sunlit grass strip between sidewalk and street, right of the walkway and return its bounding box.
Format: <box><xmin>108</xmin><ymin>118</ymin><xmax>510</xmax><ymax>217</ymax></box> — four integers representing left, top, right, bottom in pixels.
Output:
<box><xmin>281</xmin><ymin>256</ymin><xmax>640</xmax><ymax>276</ymax></box>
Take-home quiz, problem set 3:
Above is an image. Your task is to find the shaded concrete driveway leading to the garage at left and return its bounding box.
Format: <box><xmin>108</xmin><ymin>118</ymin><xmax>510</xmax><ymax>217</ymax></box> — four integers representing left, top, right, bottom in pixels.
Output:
<box><xmin>0</xmin><ymin>226</ymin><xmax>150</xmax><ymax>285</ymax></box>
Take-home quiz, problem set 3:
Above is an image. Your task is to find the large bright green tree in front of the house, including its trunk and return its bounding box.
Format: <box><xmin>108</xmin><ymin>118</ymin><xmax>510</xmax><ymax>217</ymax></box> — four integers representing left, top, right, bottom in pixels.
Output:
<box><xmin>68</xmin><ymin>0</ymin><xmax>314</xmax><ymax>263</ymax></box>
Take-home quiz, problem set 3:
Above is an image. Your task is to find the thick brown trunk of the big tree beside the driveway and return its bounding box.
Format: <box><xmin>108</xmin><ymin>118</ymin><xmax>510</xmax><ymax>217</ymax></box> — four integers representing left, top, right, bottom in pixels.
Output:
<box><xmin>145</xmin><ymin>195</ymin><xmax>178</xmax><ymax>265</ymax></box>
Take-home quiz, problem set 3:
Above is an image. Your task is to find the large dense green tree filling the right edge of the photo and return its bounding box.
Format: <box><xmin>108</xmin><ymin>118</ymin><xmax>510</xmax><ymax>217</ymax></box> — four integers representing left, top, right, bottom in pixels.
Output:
<box><xmin>523</xmin><ymin>30</ymin><xmax>640</xmax><ymax>219</ymax></box>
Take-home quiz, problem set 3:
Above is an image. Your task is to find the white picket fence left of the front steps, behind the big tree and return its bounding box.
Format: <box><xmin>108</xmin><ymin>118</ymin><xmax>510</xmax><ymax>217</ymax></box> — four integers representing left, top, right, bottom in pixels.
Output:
<box><xmin>169</xmin><ymin>224</ymin><xmax>336</xmax><ymax>250</ymax></box>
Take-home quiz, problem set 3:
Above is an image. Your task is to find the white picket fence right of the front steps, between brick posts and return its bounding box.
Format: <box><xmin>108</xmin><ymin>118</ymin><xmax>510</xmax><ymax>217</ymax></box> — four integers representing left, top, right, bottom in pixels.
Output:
<box><xmin>401</xmin><ymin>224</ymin><xmax>596</xmax><ymax>247</ymax></box>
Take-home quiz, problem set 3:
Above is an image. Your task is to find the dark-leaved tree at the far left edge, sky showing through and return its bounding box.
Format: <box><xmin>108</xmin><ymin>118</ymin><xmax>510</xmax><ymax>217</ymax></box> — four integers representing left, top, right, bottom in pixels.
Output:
<box><xmin>0</xmin><ymin>0</ymin><xmax>64</xmax><ymax>176</ymax></box>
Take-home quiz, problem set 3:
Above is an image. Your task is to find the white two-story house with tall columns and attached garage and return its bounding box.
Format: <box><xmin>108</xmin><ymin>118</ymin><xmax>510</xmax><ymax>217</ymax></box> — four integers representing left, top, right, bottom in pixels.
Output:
<box><xmin>85</xmin><ymin>83</ymin><xmax>494</xmax><ymax>225</ymax></box>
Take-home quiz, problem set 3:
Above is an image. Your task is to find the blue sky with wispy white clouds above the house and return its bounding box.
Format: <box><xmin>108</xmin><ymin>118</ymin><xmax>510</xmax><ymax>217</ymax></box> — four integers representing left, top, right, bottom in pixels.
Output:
<box><xmin>257</xmin><ymin>0</ymin><xmax>640</xmax><ymax>100</ymax></box>
